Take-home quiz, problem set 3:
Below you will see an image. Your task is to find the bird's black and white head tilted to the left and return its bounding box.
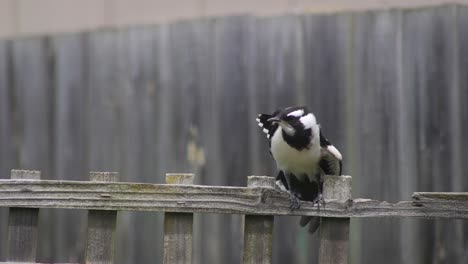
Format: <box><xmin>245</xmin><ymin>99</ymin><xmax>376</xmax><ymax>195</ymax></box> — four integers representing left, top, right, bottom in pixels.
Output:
<box><xmin>268</xmin><ymin>107</ymin><xmax>317</xmax><ymax>136</ymax></box>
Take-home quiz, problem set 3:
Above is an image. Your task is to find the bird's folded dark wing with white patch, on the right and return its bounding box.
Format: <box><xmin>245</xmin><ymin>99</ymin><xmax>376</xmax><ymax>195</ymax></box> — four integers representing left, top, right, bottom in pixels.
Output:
<box><xmin>320</xmin><ymin>129</ymin><xmax>343</xmax><ymax>175</ymax></box>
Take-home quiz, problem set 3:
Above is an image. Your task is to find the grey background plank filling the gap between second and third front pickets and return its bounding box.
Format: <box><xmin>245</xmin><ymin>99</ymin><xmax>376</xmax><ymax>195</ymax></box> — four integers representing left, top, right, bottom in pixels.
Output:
<box><xmin>115</xmin><ymin>26</ymin><xmax>164</xmax><ymax>263</ymax></box>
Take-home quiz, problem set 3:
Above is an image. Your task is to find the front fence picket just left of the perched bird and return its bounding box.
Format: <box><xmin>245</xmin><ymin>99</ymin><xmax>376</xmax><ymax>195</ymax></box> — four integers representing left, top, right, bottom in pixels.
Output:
<box><xmin>243</xmin><ymin>176</ymin><xmax>275</xmax><ymax>264</ymax></box>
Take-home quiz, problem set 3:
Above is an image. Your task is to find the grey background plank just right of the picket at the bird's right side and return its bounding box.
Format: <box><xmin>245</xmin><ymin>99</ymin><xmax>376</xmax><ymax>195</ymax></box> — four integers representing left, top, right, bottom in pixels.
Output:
<box><xmin>352</xmin><ymin>11</ymin><xmax>401</xmax><ymax>264</ymax></box>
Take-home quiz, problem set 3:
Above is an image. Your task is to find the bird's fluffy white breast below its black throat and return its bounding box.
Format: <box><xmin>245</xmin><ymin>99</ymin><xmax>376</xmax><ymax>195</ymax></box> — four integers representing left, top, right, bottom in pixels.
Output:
<box><xmin>271</xmin><ymin>125</ymin><xmax>320</xmax><ymax>180</ymax></box>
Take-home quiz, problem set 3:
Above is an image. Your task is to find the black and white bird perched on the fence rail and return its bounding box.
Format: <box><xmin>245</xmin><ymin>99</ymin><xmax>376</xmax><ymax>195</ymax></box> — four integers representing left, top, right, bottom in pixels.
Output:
<box><xmin>257</xmin><ymin>107</ymin><xmax>342</xmax><ymax>233</ymax></box>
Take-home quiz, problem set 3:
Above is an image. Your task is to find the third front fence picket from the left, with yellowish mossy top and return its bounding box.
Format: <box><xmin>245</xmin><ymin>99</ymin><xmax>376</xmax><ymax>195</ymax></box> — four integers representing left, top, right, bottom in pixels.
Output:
<box><xmin>164</xmin><ymin>173</ymin><xmax>194</xmax><ymax>264</ymax></box>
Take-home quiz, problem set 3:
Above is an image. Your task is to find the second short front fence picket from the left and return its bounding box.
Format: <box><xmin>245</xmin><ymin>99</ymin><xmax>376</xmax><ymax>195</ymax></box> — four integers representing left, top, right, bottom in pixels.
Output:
<box><xmin>86</xmin><ymin>172</ymin><xmax>119</xmax><ymax>264</ymax></box>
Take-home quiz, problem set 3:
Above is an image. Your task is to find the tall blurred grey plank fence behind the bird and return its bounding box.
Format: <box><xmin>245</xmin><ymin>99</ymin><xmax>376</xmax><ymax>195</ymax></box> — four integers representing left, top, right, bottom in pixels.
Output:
<box><xmin>0</xmin><ymin>5</ymin><xmax>468</xmax><ymax>264</ymax></box>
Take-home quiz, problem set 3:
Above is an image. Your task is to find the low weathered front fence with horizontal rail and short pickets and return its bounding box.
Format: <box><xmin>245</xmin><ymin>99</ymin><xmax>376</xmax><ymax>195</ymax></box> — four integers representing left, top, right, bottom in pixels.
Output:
<box><xmin>0</xmin><ymin>170</ymin><xmax>468</xmax><ymax>264</ymax></box>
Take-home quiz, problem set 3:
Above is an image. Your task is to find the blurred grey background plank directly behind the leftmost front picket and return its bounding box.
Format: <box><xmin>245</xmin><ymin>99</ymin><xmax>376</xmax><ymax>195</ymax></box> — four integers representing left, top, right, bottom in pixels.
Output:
<box><xmin>10</xmin><ymin>37</ymin><xmax>54</xmax><ymax>259</ymax></box>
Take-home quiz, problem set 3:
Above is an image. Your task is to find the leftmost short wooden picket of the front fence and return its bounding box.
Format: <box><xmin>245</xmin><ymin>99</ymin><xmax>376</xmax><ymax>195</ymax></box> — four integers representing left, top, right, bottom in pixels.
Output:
<box><xmin>7</xmin><ymin>170</ymin><xmax>41</xmax><ymax>262</ymax></box>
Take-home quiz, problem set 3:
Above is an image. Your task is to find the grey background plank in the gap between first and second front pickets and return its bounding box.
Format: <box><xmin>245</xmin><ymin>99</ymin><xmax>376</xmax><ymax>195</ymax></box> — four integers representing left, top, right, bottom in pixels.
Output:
<box><xmin>50</xmin><ymin>34</ymin><xmax>89</xmax><ymax>262</ymax></box>
